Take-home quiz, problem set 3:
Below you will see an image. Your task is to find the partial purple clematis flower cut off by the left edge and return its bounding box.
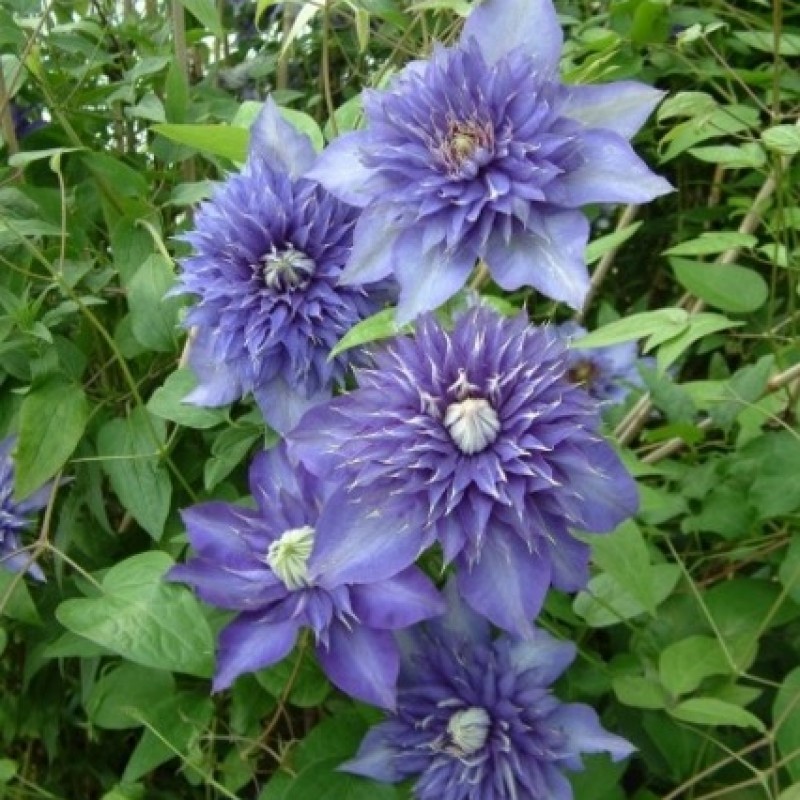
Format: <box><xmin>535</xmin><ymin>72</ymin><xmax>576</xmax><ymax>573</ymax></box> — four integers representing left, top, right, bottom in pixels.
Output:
<box><xmin>0</xmin><ymin>436</ymin><xmax>53</xmax><ymax>581</ymax></box>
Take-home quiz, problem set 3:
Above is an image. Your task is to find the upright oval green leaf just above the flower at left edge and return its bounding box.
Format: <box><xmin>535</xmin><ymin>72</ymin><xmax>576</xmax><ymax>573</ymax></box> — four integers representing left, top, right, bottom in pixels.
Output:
<box><xmin>14</xmin><ymin>378</ymin><xmax>89</xmax><ymax>499</ymax></box>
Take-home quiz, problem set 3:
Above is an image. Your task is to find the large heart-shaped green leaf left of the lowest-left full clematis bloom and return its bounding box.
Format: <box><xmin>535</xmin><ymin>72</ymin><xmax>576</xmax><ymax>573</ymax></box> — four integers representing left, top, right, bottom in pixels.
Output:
<box><xmin>56</xmin><ymin>551</ymin><xmax>214</xmax><ymax>678</ymax></box>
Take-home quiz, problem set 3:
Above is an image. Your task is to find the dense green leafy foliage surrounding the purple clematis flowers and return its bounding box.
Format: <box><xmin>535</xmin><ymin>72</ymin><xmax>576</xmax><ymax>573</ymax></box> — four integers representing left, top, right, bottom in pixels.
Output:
<box><xmin>0</xmin><ymin>0</ymin><xmax>800</xmax><ymax>800</ymax></box>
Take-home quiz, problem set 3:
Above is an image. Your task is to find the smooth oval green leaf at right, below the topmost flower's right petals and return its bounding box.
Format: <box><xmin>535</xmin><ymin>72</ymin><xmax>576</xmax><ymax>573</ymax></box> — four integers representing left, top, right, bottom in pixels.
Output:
<box><xmin>669</xmin><ymin>258</ymin><xmax>769</xmax><ymax>314</ymax></box>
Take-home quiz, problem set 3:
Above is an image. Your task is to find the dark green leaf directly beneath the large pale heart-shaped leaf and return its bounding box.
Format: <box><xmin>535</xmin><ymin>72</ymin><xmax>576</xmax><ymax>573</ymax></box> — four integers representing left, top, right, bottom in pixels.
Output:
<box><xmin>85</xmin><ymin>663</ymin><xmax>175</xmax><ymax>730</ymax></box>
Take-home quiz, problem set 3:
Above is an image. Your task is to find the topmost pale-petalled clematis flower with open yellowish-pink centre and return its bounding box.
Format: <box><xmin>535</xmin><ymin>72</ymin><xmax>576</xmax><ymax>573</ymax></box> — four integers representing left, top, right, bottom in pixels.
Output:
<box><xmin>309</xmin><ymin>0</ymin><xmax>671</xmax><ymax>322</ymax></box>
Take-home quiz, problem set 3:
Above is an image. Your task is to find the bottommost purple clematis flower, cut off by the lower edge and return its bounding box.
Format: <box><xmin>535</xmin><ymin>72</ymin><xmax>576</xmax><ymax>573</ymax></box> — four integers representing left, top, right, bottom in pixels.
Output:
<box><xmin>343</xmin><ymin>587</ymin><xmax>633</xmax><ymax>800</ymax></box>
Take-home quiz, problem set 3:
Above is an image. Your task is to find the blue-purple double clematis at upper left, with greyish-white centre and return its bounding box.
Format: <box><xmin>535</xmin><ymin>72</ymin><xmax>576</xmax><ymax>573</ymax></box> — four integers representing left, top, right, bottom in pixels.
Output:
<box><xmin>178</xmin><ymin>100</ymin><xmax>385</xmax><ymax>433</ymax></box>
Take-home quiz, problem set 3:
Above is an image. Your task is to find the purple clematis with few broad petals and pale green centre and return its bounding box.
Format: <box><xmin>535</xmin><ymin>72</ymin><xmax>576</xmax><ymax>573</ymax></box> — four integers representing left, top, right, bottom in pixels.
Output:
<box><xmin>169</xmin><ymin>445</ymin><xmax>444</xmax><ymax>708</ymax></box>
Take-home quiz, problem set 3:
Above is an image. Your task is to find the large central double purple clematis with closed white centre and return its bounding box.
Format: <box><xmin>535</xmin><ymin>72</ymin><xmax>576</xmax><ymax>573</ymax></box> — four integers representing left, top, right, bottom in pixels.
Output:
<box><xmin>290</xmin><ymin>307</ymin><xmax>638</xmax><ymax>635</ymax></box>
